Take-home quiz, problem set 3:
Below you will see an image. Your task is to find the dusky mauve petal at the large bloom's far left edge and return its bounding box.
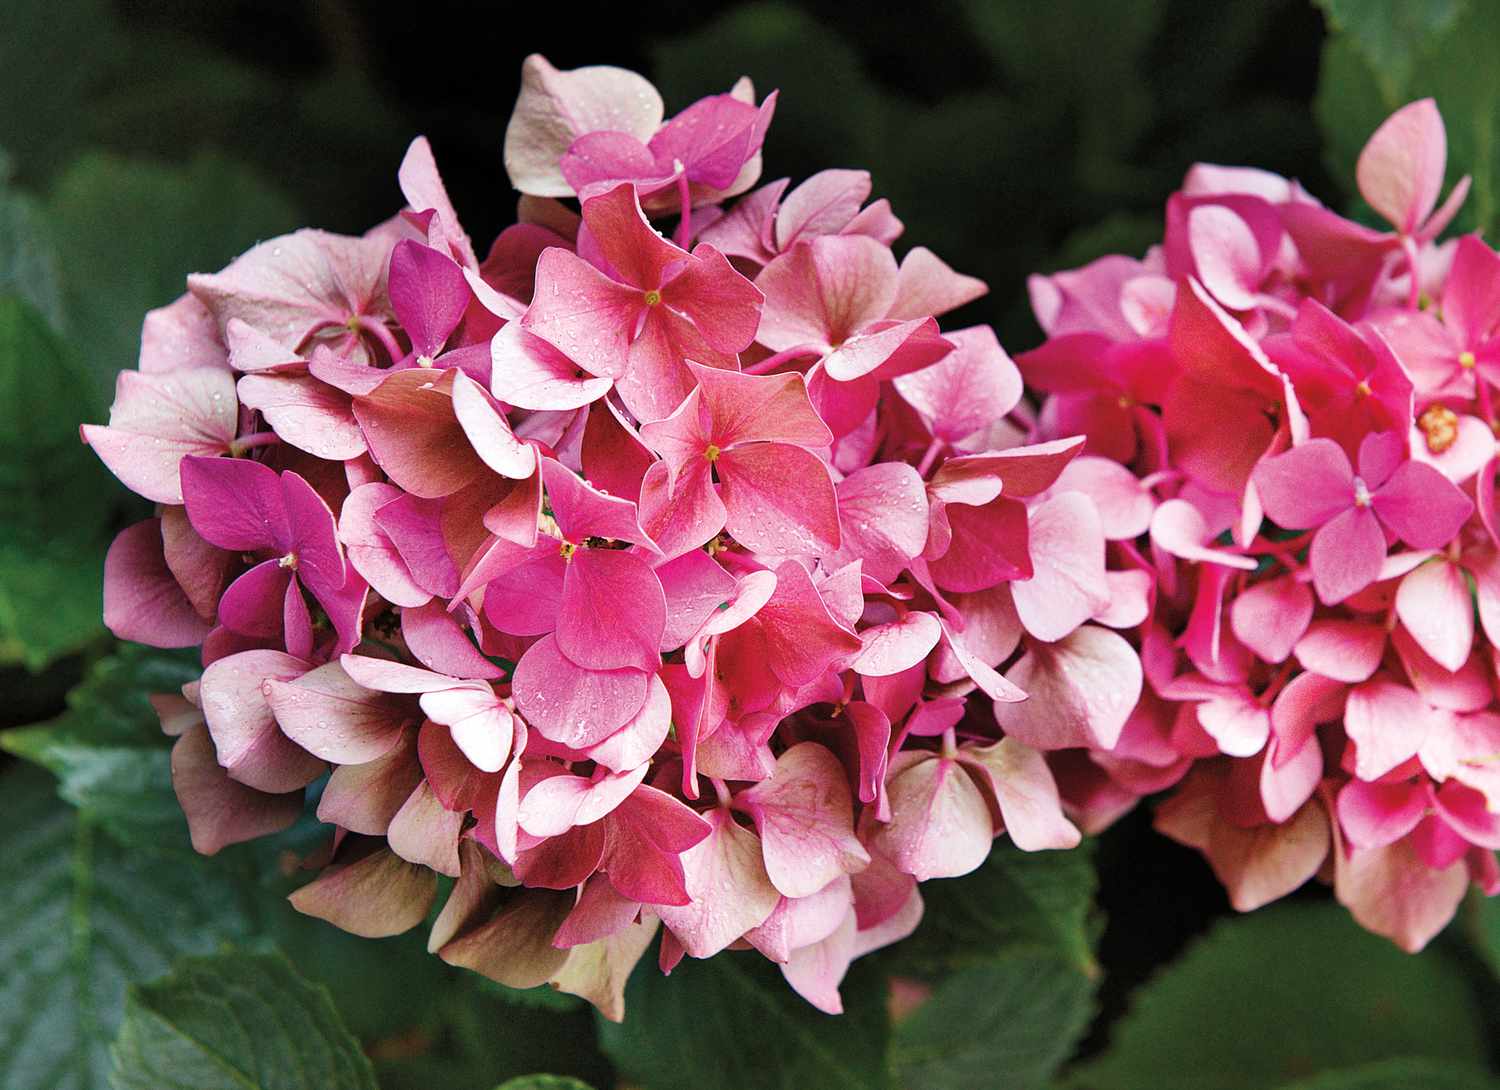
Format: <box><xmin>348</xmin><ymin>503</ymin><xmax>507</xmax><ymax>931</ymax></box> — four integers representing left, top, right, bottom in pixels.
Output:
<box><xmin>104</xmin><ymin>519</ymin><xmax>209</xmax><ymax>648</ymax></box>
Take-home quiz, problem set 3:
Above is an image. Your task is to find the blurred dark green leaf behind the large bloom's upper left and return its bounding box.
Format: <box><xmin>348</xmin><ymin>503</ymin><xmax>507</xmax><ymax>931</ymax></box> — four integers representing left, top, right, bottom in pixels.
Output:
<box><xmin>48</xmin><ymin>151</ymin><xmax>297</xmax><ymax>400</ymax></box>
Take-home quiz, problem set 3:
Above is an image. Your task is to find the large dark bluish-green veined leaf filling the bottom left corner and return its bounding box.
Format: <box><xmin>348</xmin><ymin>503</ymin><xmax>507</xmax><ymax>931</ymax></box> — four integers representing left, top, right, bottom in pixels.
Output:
<box><xmin>0</xmin><ymin>768</ymin><xmax>258</xmax><ymax>1090</ymax></box>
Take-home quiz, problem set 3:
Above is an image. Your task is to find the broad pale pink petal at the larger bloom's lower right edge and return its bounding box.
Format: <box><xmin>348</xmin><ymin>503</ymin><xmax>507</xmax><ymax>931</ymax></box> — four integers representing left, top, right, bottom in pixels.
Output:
<box><xmin>995</xmin><ymin>625</ymin><xmax>1142</xmax><ymax>750</ymax></box>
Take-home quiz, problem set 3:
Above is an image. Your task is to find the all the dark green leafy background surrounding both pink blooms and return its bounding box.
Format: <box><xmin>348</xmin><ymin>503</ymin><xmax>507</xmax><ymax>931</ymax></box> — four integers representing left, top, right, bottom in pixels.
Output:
<box><xmin>0</xmin><ymin>0</ymin><xmax>1500</xmax><ymax>1090</ymax></box>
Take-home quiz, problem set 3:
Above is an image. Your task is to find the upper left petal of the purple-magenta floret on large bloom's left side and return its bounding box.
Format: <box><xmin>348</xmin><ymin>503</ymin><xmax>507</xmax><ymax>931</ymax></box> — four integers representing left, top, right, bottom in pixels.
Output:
<box><xmin>182</xmin><ymin>457</ymin><xmax>291</xmax><ymax>552</ymax></box>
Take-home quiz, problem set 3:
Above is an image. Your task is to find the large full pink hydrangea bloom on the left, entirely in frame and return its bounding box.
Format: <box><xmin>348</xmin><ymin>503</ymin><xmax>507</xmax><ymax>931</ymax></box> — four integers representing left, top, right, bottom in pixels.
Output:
<box><xmin>84</xmin><ymin>57</ymin><xmax>1140</xmax><ymax>1018</ymax></box>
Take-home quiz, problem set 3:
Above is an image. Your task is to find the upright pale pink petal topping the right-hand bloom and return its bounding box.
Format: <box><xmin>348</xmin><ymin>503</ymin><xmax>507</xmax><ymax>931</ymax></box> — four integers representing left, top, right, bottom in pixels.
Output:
<box><xmin>1355</xmin><ymin>99</ymin><xmax>1448</xmax><ymax>235</ymax></box>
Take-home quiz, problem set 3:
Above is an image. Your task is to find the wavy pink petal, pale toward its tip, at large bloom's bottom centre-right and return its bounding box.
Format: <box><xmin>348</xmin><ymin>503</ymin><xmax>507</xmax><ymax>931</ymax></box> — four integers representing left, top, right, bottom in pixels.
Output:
<box><xmin>735</xmin><ymin>742</ymin><xmax>870</xmax><ymax>897</ymax></box>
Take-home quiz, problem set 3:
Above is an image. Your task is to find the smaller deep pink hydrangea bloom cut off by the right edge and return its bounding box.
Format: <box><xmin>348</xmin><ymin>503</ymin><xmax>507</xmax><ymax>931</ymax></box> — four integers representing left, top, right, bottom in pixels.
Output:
<box><xmin>1010</xmin><ymin>100</ymin><xmax>1500</xmax><ymax>949</ymax></box>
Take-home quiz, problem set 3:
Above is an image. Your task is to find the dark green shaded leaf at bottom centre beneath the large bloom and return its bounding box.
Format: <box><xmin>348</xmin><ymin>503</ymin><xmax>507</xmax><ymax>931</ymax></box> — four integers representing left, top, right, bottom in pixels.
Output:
<box><xmin>599</xmin><ymin>952</ymin><xmax>890</xmax><ymax>1090</ymax></box>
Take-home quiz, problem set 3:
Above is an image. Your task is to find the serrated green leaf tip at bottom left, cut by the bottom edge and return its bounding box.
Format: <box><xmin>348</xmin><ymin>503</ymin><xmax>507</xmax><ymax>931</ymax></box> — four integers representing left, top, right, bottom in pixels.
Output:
<box><xmin>110</xmin><ymin>952</ymin><xmax>375</xmax><ymax>1090</ymax></box>
